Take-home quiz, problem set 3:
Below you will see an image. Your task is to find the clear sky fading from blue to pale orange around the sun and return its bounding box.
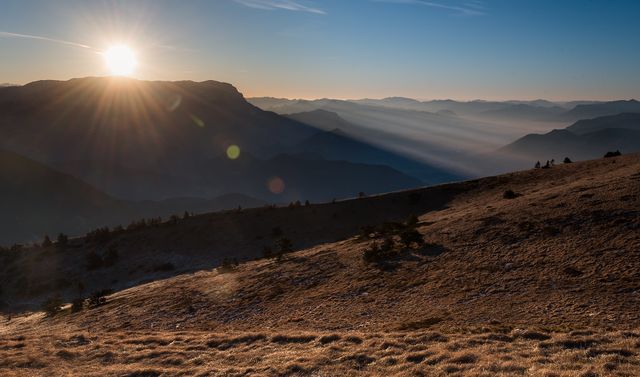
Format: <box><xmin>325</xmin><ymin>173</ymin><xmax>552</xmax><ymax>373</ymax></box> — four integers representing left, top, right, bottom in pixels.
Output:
<box><xmin>0</xmin><ymin>0</ymin><xmax>640</xmax><ymax>100</ymax></box>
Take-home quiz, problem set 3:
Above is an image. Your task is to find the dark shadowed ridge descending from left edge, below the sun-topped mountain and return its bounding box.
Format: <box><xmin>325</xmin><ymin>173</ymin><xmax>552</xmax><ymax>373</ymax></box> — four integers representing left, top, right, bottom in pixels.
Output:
<box><xmin>0</xmin><ymin>151</ymin><xmax>132</xmax><ymax>243</ymax></box>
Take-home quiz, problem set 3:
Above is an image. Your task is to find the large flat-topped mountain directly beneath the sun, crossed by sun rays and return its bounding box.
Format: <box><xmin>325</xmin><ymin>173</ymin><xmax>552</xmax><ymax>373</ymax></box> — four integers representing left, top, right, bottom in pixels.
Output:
<box><xmin>0</xmin><ymin>78</ymin><xmax>316</xmax><ymax>199</ymax></box>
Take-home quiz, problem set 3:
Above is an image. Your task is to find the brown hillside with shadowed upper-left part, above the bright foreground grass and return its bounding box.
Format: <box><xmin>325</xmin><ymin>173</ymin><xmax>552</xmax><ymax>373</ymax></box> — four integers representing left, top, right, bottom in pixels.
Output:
<box><xmin>3</xmin><ymin>154</ymin><xmax>640</xmax><ymax>322</ymax></box>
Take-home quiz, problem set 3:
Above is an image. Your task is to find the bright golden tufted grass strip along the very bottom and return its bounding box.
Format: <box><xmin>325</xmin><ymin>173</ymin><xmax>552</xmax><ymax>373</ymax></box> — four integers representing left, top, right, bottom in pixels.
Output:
<box><xmin>0</xmin><ymin>328</ymin><xmax>640</xmax><ymax>377</ymax></box>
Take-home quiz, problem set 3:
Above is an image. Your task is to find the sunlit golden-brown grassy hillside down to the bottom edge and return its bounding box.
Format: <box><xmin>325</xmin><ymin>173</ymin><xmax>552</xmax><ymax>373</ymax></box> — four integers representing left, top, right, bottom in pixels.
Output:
<box><xmin>0</xmin><ymin>155</ymin><xmax>640</xmax><ymax>377</ymax></box>
